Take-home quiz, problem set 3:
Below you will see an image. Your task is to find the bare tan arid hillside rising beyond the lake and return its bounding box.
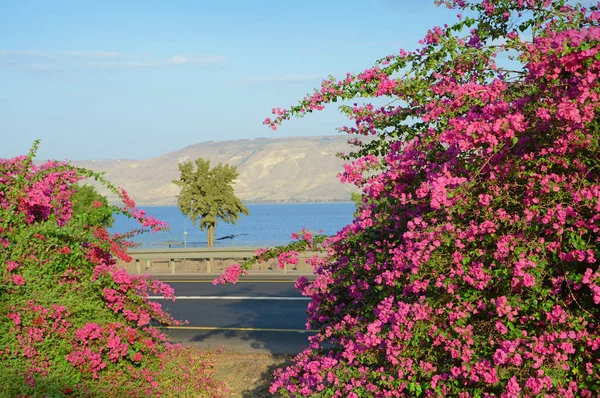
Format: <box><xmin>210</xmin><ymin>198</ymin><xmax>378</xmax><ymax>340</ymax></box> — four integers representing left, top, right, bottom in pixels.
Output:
<box><xmin>73</xmin><ymin>136</ymin><xmax>352</xmax><ymax>205</ymax></box>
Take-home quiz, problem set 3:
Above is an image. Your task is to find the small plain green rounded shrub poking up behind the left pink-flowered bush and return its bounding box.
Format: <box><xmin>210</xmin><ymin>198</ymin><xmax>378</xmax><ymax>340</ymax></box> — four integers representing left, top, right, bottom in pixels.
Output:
<box><xmin>71</xmin><ymin>184</ymin><xmax>115</xmax><ymax>228</ymax></box>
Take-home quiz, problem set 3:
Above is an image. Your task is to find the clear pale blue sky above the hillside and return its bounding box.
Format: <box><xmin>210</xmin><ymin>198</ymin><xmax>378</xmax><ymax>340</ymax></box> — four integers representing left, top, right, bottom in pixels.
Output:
<box><xmin>0</xmin><ymin>0</ymin><xmax>516</xmax><ymax>160</ymax></box>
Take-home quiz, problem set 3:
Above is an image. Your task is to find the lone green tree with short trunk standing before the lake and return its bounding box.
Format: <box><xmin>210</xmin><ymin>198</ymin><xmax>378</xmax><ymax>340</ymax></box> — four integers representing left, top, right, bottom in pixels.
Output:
<box><xmin>173</xmin><ymin>158</ymin><xmax>250</xmax><ymax>247</ymax></box>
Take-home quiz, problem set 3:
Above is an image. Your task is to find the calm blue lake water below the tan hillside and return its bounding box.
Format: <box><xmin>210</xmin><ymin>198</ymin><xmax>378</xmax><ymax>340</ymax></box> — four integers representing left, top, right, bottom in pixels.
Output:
<box><xmin>111</xmin><ymin>203</ymin><xmax>354</xmax><ymax>247</ymax></box>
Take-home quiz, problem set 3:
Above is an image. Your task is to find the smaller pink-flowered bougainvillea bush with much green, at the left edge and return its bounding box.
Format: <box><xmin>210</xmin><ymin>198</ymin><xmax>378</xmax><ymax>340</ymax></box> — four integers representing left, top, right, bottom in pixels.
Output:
<box><xmin>0</xmin><ymin>143</ymin><xmax>222</xmax><ymax>397</ymax></box>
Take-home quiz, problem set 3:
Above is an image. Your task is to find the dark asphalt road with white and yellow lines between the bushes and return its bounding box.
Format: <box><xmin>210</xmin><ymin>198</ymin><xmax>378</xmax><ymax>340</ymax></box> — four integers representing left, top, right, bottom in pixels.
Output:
<box><xmin>154</xmin><ymin>276</ymin><xmax>314</xmax><ymax>354</ymax></box>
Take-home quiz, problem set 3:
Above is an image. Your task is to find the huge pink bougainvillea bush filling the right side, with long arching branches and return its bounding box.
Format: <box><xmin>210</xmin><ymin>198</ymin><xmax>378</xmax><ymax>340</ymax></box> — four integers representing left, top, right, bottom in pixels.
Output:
<box><xmin>218</xmin><ymin>0</ymin><xmax>600</xmax><ymax>397</ymax></box>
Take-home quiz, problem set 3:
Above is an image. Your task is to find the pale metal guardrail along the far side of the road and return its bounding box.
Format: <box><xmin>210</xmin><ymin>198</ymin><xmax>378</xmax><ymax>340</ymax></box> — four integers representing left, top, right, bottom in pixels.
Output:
<box><xmin>127</xmin><ymin>247</ymin><xmax>323</xmax><ymax>274</ymax></box>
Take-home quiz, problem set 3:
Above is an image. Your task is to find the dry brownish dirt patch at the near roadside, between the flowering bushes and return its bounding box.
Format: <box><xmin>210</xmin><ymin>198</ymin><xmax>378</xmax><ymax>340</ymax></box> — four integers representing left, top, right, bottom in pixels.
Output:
<box><xmin>213</xmin><ymin>351</ymin><xmax>292</xmax><ymax>398</ymax></box>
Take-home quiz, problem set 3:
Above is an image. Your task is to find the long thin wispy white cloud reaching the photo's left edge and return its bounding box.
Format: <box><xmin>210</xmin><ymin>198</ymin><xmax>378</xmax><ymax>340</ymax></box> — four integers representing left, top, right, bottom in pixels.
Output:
<box><xmin>0</xmin><ymin>50</ymin><xmax>226</xmax><ymax>72</ymax></box>
